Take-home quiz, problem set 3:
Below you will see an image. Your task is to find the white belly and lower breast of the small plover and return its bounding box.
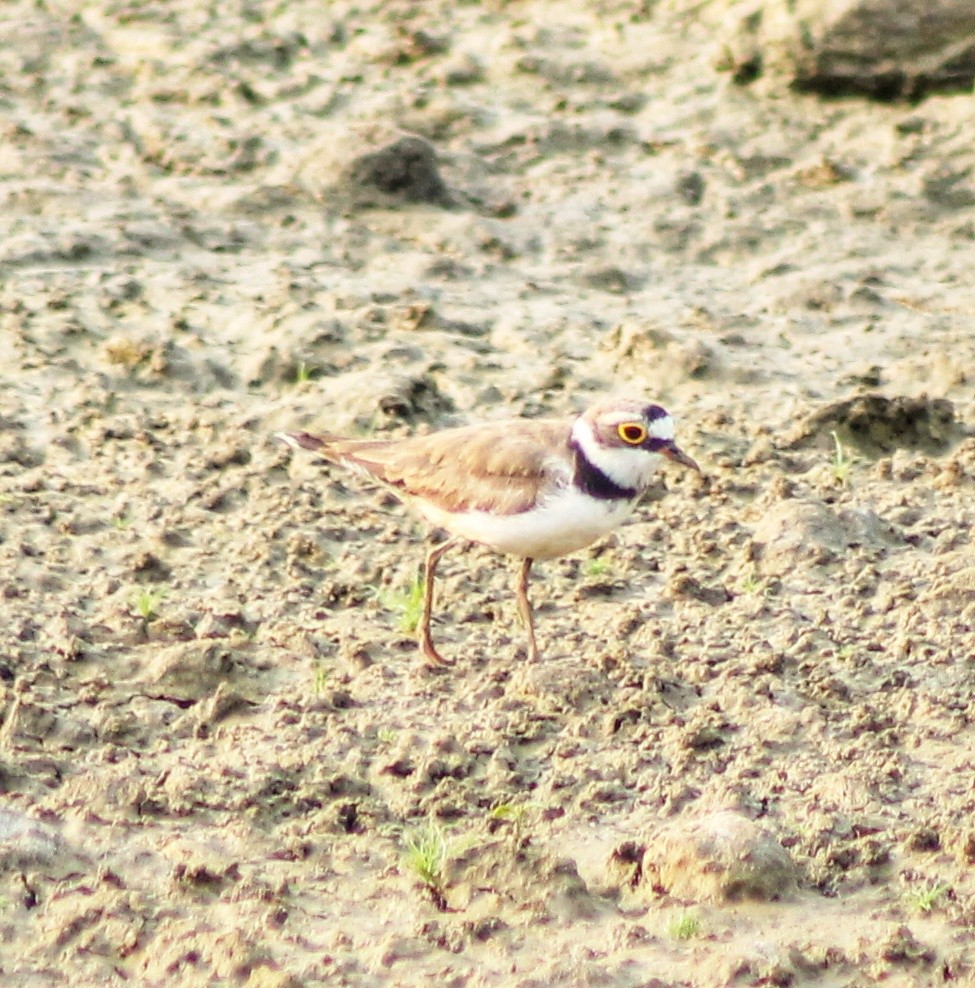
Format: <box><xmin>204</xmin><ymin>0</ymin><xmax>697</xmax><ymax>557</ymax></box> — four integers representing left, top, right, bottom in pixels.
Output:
<box><xmin>414</xmin><ymin>487</ymin><xmax>636</xmax><ymax>559</ymax></box>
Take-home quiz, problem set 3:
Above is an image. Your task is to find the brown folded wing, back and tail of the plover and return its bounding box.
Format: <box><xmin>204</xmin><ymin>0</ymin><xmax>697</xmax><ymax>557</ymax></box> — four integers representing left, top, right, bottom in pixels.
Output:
<box><xmin>290</xmin><ymin>419</ymin><xmax>571</xmax><ymax>515</ymax></box>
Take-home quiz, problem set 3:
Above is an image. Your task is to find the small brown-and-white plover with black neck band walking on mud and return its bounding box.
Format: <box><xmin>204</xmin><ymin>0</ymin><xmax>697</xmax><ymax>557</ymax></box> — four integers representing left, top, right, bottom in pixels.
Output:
<box><xmin>278</xmin><ymin>396</ymin><xmax>701</xmax><ymax>666</ymax></box>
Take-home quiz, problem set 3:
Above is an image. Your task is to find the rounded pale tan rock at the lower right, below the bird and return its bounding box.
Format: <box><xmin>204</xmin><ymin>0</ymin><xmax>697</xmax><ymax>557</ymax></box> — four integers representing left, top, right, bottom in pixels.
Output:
<box><xmin>630</xmin><ymin>810</ymin><xmax>799</xmax><ymax>902</ymax></box>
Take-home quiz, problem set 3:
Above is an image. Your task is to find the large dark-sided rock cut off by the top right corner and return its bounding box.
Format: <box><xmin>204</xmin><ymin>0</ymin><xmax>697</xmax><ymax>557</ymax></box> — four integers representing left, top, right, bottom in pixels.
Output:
<box><xmin>720</xmin><ymin>0</ymin><xmax>975</xmax><ymax>100</ymax></box>
